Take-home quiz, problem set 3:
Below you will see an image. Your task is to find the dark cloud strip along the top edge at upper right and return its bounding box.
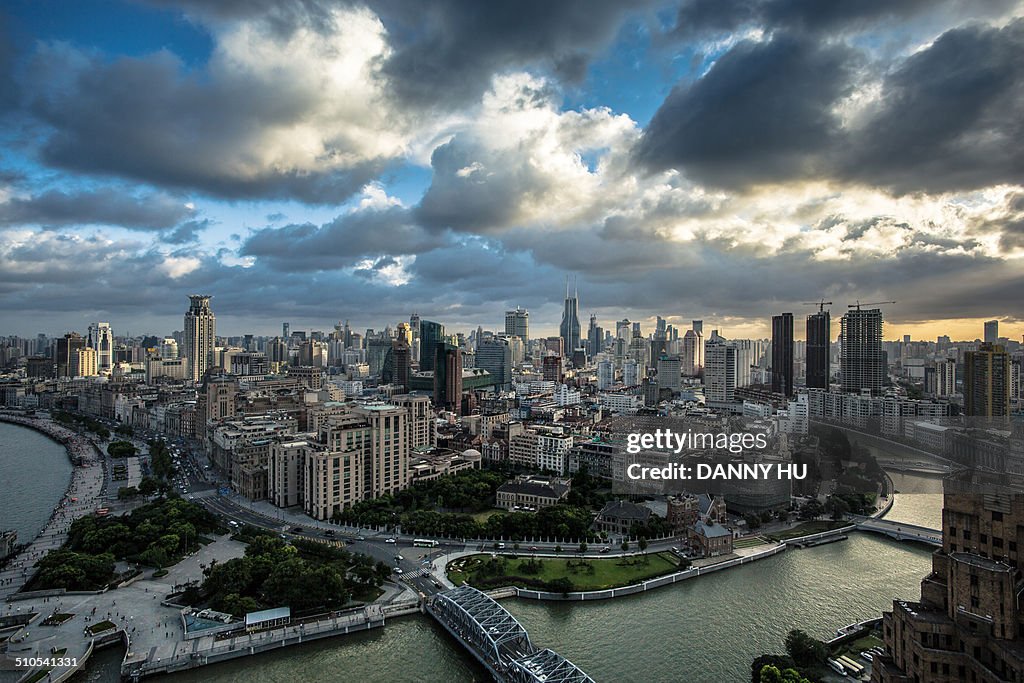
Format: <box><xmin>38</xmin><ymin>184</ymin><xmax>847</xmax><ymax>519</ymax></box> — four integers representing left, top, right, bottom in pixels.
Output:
<box><xmin>673</xmin><ymin>0</ymin><xmax>1013</xmax><ymax>39</ymax></box>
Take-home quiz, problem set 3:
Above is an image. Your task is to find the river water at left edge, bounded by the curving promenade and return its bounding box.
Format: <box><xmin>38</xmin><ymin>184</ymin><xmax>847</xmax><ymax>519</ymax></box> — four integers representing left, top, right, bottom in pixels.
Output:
<box><xmin>0</xmin><ymin>422</ymin><xmax>72</xmax><ymax>543</ymax></box>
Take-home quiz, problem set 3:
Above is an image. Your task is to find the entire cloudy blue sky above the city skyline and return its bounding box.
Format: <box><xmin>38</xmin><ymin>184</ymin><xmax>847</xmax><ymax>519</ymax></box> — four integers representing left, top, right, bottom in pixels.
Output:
<box><xmin>0</xmin><ymin>0</ymin><xmax>1024</xmax><ymax>339</ymax></box>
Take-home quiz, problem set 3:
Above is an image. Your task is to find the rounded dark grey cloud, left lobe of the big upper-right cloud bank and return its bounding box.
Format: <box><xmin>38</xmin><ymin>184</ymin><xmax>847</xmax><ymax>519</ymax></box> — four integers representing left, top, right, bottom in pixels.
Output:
<box><xmin>636</xmin><ymin>35</ymin><xmax>860</xmax><ymax>186</ymax></box>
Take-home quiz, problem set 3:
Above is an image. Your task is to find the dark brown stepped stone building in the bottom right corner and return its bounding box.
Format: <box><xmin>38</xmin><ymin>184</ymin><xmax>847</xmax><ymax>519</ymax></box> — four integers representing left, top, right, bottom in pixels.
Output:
<box><xmin>871</xmin><ymin>482</ymin><xmax>1024</xmax><ymax>683</ymax></box>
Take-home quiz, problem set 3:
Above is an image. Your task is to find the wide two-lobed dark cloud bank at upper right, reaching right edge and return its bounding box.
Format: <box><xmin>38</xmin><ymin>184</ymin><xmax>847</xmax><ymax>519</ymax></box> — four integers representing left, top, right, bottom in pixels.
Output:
<box><xmin>635</xmin><ymin>18</ymin><xmax>1024</xmax><ymax>195</ymax></box>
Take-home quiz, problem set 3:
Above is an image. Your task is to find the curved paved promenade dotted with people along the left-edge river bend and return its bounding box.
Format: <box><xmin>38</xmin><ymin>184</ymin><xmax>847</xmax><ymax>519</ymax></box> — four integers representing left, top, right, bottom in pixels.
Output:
<box><xmin>0</xmin><ymin>413</ymin><xmax>104</xmax><ymax>600</ymax></box>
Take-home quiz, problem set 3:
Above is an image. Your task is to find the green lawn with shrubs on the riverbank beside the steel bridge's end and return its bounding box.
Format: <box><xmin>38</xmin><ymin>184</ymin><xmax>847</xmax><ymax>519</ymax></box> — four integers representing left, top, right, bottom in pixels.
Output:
<box><xmin>449</xmin><ymin>553</ymin><xmax>678</xmax><ymax>591</ymax></box>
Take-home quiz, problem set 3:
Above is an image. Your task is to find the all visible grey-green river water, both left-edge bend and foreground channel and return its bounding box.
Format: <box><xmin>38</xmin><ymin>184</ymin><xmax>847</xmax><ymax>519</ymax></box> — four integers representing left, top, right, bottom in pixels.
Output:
<box><xmin>0</xmin><ymin>424</ymin><xmax>942</xmax><ymax>683</ymax></box>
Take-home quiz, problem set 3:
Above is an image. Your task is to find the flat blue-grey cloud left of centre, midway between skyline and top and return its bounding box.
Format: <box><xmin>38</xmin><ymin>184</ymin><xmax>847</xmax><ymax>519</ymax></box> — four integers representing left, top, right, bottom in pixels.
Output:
<box><xmin>240</xmin><ymin>207</ymin><xmax>445</xmax><ymax>271</ymax></box>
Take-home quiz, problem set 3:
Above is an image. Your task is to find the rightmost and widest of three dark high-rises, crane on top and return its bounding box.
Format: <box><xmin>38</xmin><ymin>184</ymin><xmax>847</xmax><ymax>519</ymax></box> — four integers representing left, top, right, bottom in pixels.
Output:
<box><xmin>839</xmin><ymin>306</ymin><xmax>887</xmax><ymax>394</ymax></box>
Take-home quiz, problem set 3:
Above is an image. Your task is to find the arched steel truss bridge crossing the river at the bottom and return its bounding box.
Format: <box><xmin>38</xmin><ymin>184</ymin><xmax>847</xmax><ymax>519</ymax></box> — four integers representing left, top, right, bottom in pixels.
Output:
<box><xmin>427</xmin><ymin>586</ymin><xmax>594</xmax><ymax>683</ymax></box>
